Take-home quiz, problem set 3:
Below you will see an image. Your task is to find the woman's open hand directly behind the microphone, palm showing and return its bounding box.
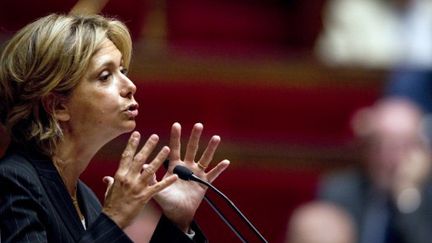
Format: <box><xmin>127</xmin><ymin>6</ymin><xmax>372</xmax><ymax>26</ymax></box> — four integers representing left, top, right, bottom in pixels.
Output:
<box><xmin>155</xmin><ymin>123</ymin><xmax>229</xmax><ymax>232</ymax></box>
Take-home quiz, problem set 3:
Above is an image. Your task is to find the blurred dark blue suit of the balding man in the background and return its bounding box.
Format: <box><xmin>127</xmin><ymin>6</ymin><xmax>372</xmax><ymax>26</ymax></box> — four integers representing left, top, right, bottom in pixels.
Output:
<box><xmin>319</xmin><ymin>170</ymin><xmax>432</xmax><ymax>243</ymax></box>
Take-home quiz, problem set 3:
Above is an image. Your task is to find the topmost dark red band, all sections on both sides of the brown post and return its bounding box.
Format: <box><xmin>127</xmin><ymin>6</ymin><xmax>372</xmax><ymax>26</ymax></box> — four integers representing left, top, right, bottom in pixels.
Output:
<box><xmin>0</xmin><ymin>0</ymin><xmax>325</xmax><ymax>51</ymax></box>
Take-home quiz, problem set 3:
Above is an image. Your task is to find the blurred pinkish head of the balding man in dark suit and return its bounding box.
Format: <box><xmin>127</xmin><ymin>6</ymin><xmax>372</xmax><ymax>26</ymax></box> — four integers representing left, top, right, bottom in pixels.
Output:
<box><xmin>357</xmin><ymin>99</ymin><xmax>429</xmax><ymax>190</ymax></box>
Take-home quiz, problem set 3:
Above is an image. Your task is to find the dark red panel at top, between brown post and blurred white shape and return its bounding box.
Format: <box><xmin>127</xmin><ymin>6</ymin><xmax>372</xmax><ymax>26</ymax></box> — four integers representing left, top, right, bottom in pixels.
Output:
<box><xmin>167</xmin><ymin>0</ymin><xmax>324</xmax><ymax>48</ymax></box>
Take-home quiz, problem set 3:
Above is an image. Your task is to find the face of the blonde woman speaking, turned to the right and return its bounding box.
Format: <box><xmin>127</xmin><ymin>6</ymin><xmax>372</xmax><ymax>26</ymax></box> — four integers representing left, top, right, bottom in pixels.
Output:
<box><xmin>66</xmin><ymin>39</ymin><xmax>138</xmax><ymax>140</ymax></box>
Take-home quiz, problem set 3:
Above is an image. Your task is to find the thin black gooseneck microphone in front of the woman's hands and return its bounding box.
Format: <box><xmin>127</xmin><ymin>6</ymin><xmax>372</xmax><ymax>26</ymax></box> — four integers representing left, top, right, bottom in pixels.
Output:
<box><xmin>173</xmin><ymin>165</ymin><xmax>268</xmax><ymax>243</ymax></box>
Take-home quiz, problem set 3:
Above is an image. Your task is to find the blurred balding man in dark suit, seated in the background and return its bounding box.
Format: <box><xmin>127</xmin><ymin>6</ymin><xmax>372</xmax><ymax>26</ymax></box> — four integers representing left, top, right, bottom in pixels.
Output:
<box><xmin>319</xmin><ymin>98</ymin><xmax>432</xmax><ymax>243</ymax></box>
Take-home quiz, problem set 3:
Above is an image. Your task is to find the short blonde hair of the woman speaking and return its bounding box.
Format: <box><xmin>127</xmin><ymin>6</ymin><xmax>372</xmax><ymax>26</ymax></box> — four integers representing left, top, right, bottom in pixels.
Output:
<box><xmin>0</xmin><ymin>14</ymin><xmax>132</xmax><ymax>155</ymax></box>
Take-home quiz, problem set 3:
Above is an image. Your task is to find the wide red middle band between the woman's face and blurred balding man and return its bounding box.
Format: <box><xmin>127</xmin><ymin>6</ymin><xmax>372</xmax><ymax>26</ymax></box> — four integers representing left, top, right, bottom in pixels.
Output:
<box><xmin>127</xmin><ymin>80</ymin><xmax>378</xmax><ymax>144</ymax></box>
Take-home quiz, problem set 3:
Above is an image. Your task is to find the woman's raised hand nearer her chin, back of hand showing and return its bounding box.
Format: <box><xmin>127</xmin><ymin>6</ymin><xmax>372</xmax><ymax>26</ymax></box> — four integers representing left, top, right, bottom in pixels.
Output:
<box><xmin>103</xmin><ymin>132</ymin><xmax>177</xmax><ymax>228</ymax></box>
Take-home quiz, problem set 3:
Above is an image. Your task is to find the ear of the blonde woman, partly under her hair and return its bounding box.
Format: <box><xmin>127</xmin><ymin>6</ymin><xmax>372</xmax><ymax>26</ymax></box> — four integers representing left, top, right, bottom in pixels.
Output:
<box><xmin>42</xmin><ymin>93</ymin><xmax>70</xmax><ymax>122</ymax></box>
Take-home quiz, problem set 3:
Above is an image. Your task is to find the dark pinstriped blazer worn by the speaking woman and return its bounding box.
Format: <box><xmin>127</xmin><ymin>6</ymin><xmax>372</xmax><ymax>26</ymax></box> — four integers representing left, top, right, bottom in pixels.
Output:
<box><xmin>0</xmin><ymin>146</ymin><xmax>206</xmax><ymax>243</ymax></box>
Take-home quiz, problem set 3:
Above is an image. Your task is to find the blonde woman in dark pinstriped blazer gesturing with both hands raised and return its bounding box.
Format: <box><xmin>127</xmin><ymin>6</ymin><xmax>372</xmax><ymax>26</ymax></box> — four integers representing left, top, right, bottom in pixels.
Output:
<box><xmin>0</xmin><ymin>14</ymin><xmax>229</xmax><ymax>242</ymax></box>
